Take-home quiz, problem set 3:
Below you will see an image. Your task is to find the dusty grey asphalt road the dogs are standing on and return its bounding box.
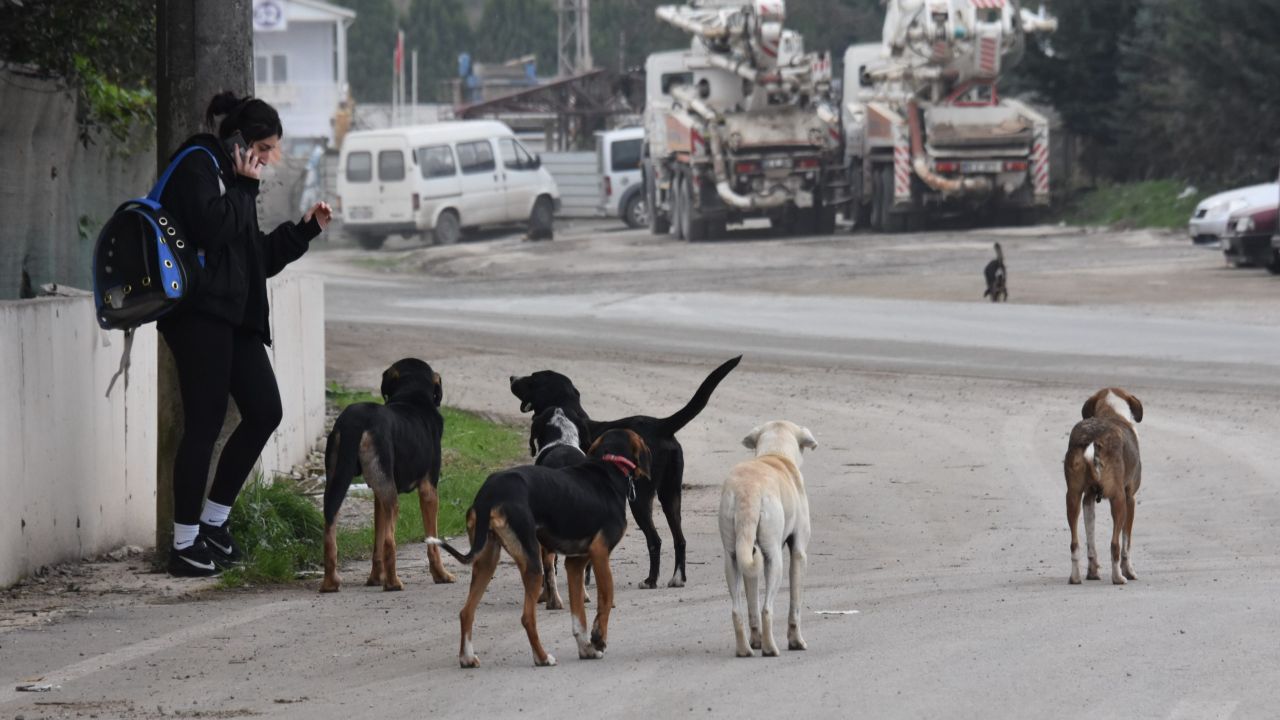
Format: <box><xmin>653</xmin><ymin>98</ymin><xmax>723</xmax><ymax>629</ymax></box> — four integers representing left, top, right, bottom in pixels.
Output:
<box><xmin>0</xmin><ymin>224</ymin><xmax>1280</xmax><ymax>719</ymax></box>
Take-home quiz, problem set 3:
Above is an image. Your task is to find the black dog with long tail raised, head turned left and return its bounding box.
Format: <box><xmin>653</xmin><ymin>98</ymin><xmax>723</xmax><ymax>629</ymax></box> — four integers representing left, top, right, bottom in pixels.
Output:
<box><xmin>511</xmin><ymin>355</ymin><xmax>742</xmax><ymax>588</ymax></box>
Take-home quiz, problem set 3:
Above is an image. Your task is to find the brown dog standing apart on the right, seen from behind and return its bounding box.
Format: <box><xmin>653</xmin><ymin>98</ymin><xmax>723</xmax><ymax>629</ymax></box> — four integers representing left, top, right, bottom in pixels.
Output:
<box><xmin>1062</xmin><ymin>387</ymin><xmax>1142</xmax><ymax>585</ymax></box>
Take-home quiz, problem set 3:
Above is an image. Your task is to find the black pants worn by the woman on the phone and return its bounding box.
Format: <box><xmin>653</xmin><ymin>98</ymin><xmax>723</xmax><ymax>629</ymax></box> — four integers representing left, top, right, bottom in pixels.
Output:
<box><xmin>164</xmin><ymin>313</ymin><xmax>283</xmax><ymax>525</ymax></box>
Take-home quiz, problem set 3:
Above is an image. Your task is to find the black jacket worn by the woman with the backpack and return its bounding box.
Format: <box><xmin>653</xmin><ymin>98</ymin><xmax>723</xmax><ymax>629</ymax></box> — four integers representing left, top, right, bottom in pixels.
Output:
<box><xmin>159</xmin><ymin>133</ymin><xmax>320</xmax><ymax>345</ymax></box>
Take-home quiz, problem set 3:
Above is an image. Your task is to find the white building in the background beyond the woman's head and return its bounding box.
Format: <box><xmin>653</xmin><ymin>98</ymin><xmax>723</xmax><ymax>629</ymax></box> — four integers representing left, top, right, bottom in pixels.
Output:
<box><xmin>253</xmin><ymin>0</ymin><xmax>356</xmax><ymax>145</ymax></box>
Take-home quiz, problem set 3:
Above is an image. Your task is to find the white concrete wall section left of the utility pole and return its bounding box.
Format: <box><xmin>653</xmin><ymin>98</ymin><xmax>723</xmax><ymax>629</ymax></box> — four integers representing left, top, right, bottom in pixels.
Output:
<box><xmin>0</xmin><ymin>296</ymin><xmax>156</xmax><ymax>587</ymax></box>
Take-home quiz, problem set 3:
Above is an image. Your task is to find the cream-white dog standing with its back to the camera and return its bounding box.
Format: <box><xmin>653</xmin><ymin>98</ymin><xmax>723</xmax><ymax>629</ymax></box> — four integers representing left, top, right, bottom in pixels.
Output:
<box><xmin>719</xmin><ymin>420</ymin><xmax>818</xmax><ymax>657</ymax></box>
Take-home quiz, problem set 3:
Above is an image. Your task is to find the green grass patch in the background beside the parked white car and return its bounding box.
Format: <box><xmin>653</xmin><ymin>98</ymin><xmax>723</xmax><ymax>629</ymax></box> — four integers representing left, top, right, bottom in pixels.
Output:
<box><xmin>1064</xmin><ymin>179</ymin><xmax>1207</xmax><ymax>229</ymax></box>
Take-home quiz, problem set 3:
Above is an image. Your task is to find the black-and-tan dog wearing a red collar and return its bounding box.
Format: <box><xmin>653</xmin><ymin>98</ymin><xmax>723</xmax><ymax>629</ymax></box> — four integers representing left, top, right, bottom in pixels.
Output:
<box><xmin>426</xmin><ymin>430</ymin><xmax>649</xmax><ymax>667</ymax></box>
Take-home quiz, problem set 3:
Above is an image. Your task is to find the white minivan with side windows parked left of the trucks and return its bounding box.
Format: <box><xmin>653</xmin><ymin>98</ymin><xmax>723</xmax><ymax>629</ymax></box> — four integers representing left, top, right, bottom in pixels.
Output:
<box><xmin>338</xmin><ymin>120</ymin><xmax>559</xmax><ymax>250</ymax></box>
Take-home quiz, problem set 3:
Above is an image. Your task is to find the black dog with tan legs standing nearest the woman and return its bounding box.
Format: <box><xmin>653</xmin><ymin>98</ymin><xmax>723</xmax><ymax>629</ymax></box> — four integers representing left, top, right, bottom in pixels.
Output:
<box><xmin>320</xmin><ymin>357</ymin><xmax>453</xmax><ymax>592</ymax></box>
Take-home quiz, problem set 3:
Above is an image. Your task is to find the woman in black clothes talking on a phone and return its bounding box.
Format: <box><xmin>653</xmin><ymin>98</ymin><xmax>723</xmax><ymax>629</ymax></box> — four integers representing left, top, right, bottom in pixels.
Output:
<box><xmin>157</xmin><ymin>92</ymin><xmax>332</xmax><ymax>577</ymax></box>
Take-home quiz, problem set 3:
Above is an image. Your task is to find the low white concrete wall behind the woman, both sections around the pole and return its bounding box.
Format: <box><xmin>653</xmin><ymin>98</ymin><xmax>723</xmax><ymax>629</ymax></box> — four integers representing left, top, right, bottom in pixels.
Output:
<box><xmin>0</xmin><ymin>272</ymin><xmax>325</xmax><ymax>588</ymax></box>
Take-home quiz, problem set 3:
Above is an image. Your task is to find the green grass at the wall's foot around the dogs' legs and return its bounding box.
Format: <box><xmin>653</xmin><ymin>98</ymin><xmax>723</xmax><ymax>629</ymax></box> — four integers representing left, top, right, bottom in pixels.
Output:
<box><xmin>221</xmin><ymin>383</ymin><xmax>527</xmax><ymax>587</ymax></box>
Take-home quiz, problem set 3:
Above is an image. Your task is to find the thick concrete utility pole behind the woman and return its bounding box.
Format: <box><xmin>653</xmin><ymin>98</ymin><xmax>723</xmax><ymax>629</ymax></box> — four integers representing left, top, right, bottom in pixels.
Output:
<box><xmin>156</xmin><ymin>0</ymin><xmax>253</xmax><ymax>550</ymax></box>
